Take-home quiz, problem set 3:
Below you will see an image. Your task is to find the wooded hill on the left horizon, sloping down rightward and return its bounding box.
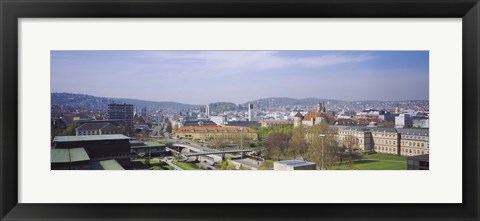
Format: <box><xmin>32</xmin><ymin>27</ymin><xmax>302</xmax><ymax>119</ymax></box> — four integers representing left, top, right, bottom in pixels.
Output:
<box><xmin>51</xmin><ymin>93</ymin><xmax>200</xmax><ymax>110</ymax></box>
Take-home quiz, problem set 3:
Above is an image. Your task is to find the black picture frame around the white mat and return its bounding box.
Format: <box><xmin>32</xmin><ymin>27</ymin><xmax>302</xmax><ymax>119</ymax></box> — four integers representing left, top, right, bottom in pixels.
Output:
<box><xmin>0</xmin><ymin>0</ymin><xmax>480</xmax><ymax>220</ymax></box>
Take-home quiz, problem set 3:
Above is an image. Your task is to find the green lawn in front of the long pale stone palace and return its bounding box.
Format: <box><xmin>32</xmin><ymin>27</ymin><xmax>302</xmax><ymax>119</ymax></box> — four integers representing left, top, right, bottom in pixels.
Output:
<box><xmin>329</xmin><ymin>160</ymin><xmax>407</xmax><ymax>170</ymax></box>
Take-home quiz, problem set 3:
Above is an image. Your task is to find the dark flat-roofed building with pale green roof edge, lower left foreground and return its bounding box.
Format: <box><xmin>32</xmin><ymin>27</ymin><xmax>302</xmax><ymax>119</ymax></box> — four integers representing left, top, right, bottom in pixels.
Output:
<box><xmin>53</xmin><ymin>134</ymin><xmax>130</xmax><ymax>164</ymax></box>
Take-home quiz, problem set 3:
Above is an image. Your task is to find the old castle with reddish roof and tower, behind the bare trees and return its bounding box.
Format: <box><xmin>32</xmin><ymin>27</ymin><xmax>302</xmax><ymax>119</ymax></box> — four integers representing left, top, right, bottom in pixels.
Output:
<box><xmin>293</xmin><ymin>102</ymin><xmax>336</xmax><ymax>127</ymax></box>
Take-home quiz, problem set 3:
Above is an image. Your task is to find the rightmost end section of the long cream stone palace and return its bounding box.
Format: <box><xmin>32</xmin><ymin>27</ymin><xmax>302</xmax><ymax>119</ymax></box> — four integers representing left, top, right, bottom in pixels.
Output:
<box><xmin>397</xmin><ymin>128</ymin><xmax>430</xmax><ymax>156</ymax></box>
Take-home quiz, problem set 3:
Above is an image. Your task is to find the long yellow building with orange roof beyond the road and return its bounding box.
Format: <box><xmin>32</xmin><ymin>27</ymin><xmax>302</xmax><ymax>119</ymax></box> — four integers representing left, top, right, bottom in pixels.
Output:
<box><xmin>176</xmin><ymin>126</ymin><xmax>258</xmax><ymax>140</ymax></box>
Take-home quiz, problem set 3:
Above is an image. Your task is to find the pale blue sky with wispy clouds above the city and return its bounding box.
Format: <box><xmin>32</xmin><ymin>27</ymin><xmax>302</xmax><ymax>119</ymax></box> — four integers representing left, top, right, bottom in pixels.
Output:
<box><xmin>51</xmin><ymin>51</ymin><xmax>429</xmax><ymax>104</ymax></box>
